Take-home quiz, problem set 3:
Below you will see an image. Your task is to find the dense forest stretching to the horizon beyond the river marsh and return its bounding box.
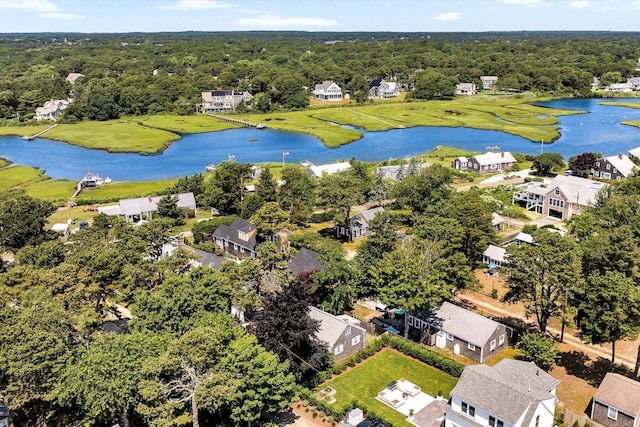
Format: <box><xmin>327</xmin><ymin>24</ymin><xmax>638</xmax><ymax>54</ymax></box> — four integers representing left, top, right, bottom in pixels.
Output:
<box><xmin>0</xmin><ymin>32</ymin><xmax>640</xmax><ymax>122</ymax></box>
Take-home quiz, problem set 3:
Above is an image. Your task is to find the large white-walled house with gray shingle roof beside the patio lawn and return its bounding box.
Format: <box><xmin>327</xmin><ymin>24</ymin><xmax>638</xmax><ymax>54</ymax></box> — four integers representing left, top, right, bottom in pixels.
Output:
<box><xmin>445</xmin><ymin>359</ymin><xmax>559</xmax><ymax>427</ymax></box>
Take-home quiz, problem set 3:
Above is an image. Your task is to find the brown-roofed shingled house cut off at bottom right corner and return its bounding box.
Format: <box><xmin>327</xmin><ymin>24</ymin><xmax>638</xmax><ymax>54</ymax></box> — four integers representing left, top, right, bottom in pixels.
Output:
<box><xmin>591</xmin><ymin>372</ymin><xmax>640</xmax><ymax>427</ymax></box>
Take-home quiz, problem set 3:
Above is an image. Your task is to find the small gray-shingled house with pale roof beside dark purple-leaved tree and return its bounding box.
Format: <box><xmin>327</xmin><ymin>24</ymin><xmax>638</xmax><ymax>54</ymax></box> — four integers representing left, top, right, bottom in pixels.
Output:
<box><xmin>309</xmin><ymin>307</ymin><xmax>367</xmax><ymax>362</ymax></box>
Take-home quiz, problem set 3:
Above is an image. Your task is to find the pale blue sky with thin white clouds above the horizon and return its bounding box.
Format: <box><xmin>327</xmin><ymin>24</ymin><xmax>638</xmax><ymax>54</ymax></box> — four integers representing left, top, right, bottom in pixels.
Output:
<box><xmin>0</xmin><ymin>0</ymin><xmax>640</xmax><ymax>33</ymax></box>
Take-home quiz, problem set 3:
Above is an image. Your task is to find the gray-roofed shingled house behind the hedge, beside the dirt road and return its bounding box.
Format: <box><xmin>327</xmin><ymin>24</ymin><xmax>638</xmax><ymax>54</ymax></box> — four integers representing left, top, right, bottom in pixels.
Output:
<box><xmin>409</xmin><ymin>302</ymin><xmax>509</xmax><ymax>363</ymax></box>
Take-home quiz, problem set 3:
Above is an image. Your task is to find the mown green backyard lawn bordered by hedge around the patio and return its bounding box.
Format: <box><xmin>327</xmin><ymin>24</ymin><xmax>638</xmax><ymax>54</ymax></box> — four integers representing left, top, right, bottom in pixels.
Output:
<box><xmin>320</xmin><ymin>349</ymin><xmax>458</xmax><ymax>426</ymax></box>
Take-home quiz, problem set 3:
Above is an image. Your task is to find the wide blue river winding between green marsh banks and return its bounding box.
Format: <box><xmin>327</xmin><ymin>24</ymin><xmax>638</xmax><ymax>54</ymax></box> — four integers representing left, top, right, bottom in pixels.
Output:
<box><xmin>0</xmin><ymin>99</ymin><xmax>640</xmax><ymax>181</ymax></box>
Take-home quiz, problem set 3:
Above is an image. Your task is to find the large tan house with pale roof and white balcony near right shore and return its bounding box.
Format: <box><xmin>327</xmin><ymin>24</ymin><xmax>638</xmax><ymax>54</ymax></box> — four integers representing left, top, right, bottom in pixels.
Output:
<box><xmin>513</xmin><ymin>175</ymin><xmax>605</xmax><ymax>219</ymax></box>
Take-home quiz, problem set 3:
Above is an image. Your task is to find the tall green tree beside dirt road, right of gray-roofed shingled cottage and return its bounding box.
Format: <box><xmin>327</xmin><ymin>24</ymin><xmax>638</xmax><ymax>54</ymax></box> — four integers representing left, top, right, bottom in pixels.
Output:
<box><xmin>503</xmin><ymin>228</ymin><xmax>582</xmax><ymax>332</ymax></box>
